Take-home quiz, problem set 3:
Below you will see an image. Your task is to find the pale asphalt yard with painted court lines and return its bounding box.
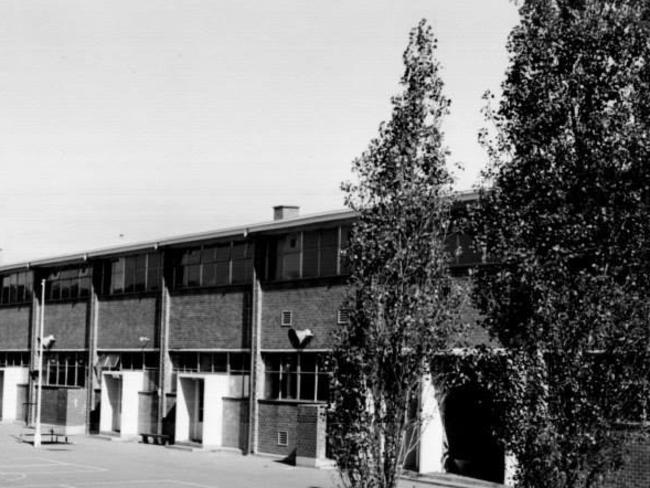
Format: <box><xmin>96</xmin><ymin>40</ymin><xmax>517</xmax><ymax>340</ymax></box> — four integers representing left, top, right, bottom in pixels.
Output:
<box><xmin>0</xmin><ymin>424</ymin><xmax>460</xmax><ymax>488</ymax></box>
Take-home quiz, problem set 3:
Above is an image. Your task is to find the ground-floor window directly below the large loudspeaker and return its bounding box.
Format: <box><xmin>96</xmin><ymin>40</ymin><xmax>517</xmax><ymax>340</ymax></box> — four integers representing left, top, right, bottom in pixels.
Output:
<box><xmin>264</xmin><ymin>353</ymin><xmax>330</xmax><ymax>402</ymax></box>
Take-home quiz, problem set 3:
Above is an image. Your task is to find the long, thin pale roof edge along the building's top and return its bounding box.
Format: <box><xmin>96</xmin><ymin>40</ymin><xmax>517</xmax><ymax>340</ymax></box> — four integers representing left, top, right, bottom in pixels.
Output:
<box><xmin>0</xmin><ymin>190</ymin><xmax>478</xmax><ymax>272</ymax></box>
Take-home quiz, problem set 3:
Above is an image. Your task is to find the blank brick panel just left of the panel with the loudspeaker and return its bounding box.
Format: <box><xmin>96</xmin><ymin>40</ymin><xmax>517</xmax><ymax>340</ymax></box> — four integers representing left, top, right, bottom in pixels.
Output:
<box><xmin>169</xmin><ymin>290</ymin><xmax>250</xmax><ymax>349</ymax></box>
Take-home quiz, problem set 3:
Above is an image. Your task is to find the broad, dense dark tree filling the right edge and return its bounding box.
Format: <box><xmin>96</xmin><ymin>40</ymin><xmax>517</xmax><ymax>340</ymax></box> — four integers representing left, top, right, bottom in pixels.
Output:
<box><xmin>474</xmin><ymin>0</ymin><xmax>650</xmax><ymax>488</ymax></box>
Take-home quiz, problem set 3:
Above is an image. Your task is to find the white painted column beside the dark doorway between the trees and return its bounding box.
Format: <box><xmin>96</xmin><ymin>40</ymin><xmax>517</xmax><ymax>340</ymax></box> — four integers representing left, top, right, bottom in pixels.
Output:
<box><xmin>418</xmin><ymin>375</ymin><xmax>445</xmax><ymax>474</ymax></box>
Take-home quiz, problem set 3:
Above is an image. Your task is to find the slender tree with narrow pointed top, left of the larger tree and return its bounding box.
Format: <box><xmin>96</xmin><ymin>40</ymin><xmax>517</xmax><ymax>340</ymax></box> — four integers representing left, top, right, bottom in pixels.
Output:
<box><xmin>330</xmin><ymin>20</ymin><xmax>454</xmax><ymax>488</ymax></box>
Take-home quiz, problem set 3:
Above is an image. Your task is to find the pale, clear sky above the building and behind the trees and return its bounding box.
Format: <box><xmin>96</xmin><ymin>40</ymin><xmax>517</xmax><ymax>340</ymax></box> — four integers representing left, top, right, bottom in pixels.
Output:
<box><xmin>0</xmin><ymin>0</ymin><xmax>517</xmax><ymax>264</ymax></box>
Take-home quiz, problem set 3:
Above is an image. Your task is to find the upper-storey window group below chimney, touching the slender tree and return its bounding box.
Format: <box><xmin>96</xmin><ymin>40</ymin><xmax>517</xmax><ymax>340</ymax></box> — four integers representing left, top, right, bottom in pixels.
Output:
<box><xmin>267</xmin><ymin>227</ymin><xmax>350</xmax><ymax>280</ymax></box>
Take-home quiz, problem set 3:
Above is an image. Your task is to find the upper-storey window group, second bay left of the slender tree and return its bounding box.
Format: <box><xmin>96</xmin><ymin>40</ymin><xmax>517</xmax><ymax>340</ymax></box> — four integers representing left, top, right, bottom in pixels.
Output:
<box><xmin>173</xmin><ymin>241</ymin><xmax>253</xmax><ymax>288</ymax></box>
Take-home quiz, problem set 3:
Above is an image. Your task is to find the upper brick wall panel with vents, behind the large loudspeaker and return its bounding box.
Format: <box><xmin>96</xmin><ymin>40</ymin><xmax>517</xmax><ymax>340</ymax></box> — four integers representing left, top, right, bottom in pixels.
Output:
<box><xmin>262</xmin><ymin>283</ymin><xmax>346</xmax><ymax>349</ymax></box>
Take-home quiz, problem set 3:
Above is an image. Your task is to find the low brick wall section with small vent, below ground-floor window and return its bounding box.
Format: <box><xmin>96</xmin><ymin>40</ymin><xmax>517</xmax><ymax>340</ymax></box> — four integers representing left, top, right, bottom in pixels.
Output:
<box><xmin>258</xmin><ymin>401</ymin><xmax>298</xmax><ymax>456</ymax></box>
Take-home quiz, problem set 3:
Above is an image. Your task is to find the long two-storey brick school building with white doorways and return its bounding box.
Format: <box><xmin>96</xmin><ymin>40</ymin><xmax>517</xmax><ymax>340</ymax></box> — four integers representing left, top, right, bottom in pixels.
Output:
<box><xmin>0</xmin><ymin>195</ymin><xmax>502</xmax><ymax>471</ymax></box>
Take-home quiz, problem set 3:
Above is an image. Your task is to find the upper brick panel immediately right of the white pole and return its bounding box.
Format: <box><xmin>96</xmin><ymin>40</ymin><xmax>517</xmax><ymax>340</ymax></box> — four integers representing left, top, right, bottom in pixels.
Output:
<box><xmin>44</xmin><ymin>301</ymin><xmax>90</xmax><ymax>350</ymax></box>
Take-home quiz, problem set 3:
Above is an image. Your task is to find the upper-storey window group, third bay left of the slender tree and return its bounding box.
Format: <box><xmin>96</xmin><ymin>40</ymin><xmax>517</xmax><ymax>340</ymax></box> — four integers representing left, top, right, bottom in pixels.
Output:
<box><xmin>104</xmin><ymin>252</ymin><xmax>162</xmax><ymax>295</ymax></box>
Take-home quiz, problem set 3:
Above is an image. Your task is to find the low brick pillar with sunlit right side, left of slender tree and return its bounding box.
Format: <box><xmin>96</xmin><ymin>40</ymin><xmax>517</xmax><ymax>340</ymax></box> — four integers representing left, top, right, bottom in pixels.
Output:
<box><xmin>296</xmin><ymin>405</ymin><xmax>331</xmax><ymax>468</ymax></box>
